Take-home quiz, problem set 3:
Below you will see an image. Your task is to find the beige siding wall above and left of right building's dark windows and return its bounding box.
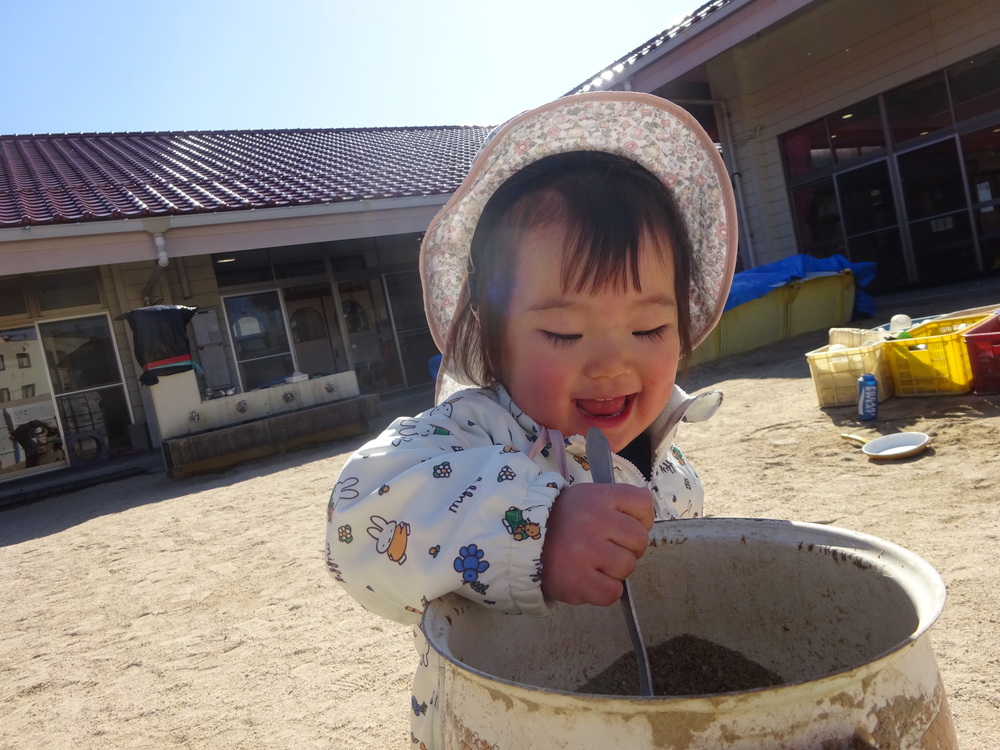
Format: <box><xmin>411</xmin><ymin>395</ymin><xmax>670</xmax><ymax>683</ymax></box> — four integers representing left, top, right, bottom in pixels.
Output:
<box><xmin>709</xmin><ymin>0</ymin><xmax>1000</xmax><ymax>264</ymax></box>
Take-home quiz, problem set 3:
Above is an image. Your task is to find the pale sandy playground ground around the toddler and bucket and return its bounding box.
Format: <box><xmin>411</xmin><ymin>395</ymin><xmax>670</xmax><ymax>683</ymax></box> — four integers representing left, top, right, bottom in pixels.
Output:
<box><xmin>0</xmin><ymin>304</ymin><xmax>1000</xmax><ymax>750</ymax></box>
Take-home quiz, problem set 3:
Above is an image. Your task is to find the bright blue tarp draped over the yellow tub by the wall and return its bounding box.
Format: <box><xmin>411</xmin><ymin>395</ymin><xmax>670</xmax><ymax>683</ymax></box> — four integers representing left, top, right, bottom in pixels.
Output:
<box><xmin>725</xmin><ymin>255</ymin><xmax>875</xmax><ymax>317</ymax></box>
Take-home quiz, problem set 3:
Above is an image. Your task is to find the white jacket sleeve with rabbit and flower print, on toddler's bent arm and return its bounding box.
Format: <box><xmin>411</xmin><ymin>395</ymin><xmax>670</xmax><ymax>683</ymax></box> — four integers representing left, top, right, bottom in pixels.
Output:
<box><xmin>326</xmin><ymin>402</ymin><xmax>566</xmax><ymax>623</ymax></box>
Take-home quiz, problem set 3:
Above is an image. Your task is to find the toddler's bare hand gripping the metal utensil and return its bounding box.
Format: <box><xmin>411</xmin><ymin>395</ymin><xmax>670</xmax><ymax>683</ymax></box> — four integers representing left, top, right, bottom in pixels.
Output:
<box><xmin>542</xmin><ymin>483</ymin><xmax>654</xmax><ymax>606</ymax></box>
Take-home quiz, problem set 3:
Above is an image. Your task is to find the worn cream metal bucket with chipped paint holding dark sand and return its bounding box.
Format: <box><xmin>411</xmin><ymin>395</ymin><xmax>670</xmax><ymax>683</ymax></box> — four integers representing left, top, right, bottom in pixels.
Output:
<box><xmin>422</xmin><ymin>518</ymin><xmax>957</xmax><ymax>750</ymax></box>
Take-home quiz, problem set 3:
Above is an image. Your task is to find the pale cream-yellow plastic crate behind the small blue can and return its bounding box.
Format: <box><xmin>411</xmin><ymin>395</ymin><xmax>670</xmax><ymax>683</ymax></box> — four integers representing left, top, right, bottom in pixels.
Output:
<box><xmin>806</xmin><ymin>328</ymin><xmax>893</xmax><ymax>408</ymax></box>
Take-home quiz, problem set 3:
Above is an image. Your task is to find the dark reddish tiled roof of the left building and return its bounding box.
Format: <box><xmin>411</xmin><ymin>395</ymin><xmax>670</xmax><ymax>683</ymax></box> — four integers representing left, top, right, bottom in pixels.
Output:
<box><xmin>0</xmin><ymin>126</ymin><xmax>490</xmax><ymax>228</ymax></box>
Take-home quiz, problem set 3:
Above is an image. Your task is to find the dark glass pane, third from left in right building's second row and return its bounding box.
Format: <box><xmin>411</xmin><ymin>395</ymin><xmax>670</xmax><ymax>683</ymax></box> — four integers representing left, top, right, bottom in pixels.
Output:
<box><xmin>899</xmin><ymin>138</ymin><xmax>965</xmax><ymax>221</ymax></box>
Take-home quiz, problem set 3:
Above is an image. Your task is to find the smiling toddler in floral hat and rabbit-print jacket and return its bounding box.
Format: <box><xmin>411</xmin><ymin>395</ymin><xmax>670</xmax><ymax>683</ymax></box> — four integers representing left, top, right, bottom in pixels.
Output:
<box><xmin>326</xmin><ymin>92</ymin><xmax>736</xmax><ymax>748</ymax></box>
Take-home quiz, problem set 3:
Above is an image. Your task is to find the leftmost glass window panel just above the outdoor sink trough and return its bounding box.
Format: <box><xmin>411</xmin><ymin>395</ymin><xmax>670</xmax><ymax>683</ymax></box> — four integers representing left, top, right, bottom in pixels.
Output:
<box><xmin>224</xmin><ymin>291</ymin><xmax>295</xmax><ymax>391</ymax></box>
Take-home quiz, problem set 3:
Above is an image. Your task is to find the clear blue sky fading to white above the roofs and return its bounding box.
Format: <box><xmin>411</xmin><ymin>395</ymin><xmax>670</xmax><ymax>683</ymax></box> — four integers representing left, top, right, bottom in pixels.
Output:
<box><xmin>0</xmin><ymin>0</ymin><xmax>705</xmax><ymax>135</ymax></box>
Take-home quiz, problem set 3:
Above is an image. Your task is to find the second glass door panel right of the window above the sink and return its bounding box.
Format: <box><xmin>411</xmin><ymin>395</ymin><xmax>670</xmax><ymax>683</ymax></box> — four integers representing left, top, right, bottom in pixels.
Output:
<box><xmin>339</xmin><ymin>279</ymin><xmax>403</xmax><ymax>393</ymax></box>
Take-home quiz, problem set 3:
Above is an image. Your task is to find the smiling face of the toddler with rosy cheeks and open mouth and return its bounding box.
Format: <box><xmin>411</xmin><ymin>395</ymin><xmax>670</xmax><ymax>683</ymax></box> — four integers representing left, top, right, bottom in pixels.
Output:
<box><xmin>504</xmin><ymin>217</ymin><xmax>680</xmax><ymax>451</ymax></box>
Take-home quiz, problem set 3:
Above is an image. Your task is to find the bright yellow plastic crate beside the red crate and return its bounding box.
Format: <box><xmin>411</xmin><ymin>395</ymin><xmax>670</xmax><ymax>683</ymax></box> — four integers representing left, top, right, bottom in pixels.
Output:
<box><xmin>885</xmin><ymin>315</ymin><xmax>987</xmax><ymax>396</ymax></box>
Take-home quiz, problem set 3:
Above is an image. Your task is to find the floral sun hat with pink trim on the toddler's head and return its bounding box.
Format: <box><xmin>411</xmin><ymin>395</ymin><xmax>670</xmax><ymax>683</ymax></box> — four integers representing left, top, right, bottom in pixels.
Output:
<box><xmin>420</xmin><ymin>91</ymin><xmax>737</xmax><ymax>398</ymax></box>
